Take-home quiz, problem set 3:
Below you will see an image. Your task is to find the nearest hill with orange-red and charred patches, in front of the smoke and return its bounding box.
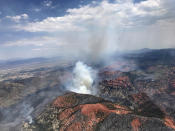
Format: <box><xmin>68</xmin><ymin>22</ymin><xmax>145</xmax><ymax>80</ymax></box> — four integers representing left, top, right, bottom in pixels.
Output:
<box><xmin>24</xmin><ymin>93</ymin><xmax>175</xmax><ymax>131</ymax></box>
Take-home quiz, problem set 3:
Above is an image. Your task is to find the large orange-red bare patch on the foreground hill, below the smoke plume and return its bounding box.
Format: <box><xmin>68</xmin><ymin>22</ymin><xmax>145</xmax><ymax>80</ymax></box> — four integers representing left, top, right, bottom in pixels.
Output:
<box><xmin>52</xmin><ymin>93</ymin><xmax>132</xmax><ymax>131</ymax></box>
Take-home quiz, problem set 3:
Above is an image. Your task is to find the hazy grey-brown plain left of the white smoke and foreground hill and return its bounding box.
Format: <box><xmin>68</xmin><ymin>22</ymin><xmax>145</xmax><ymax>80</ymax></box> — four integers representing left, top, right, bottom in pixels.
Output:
<box><xmin>0</xmin><ymin>59</ymin><xmax>72</xmax><ymax>131</ymax></box>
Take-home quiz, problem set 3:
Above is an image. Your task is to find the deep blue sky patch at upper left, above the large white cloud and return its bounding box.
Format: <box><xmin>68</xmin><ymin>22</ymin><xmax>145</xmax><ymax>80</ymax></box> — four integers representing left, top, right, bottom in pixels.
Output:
<box><xmin>0</xmin><ymin>0</ymin><xmax>91</xmax><ymax>20</ymax></box>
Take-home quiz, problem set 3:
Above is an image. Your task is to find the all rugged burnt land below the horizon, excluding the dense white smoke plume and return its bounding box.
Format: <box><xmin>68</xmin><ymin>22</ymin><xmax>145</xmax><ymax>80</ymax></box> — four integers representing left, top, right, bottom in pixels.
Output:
<box><xmin>0</xmin><ymin>49</ymin><xmax>175</xmax><ymax>131</ymax></box>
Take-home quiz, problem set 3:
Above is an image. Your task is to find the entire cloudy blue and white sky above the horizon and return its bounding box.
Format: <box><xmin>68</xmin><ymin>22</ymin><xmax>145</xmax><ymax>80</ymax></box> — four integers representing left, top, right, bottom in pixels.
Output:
<box><xmin>0</xmin><ymin>0</ymin><xmax>175</xmax><ymax>60</ymax></box>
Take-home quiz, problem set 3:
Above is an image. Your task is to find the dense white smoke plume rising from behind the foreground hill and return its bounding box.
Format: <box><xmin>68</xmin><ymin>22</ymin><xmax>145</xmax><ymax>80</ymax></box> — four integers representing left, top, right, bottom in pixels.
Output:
<box><xmin>68</xmin><ymin>61</ymin><xmax>96</xmax><ymax>94</ymax></box>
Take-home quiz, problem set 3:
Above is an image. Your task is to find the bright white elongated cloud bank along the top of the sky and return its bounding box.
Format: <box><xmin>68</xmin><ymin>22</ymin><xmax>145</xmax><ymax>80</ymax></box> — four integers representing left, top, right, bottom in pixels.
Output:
<box><xmin>17</xmin><ymin>0</ymin><xmax>171</xmax><ymax>32</ymax></box>
